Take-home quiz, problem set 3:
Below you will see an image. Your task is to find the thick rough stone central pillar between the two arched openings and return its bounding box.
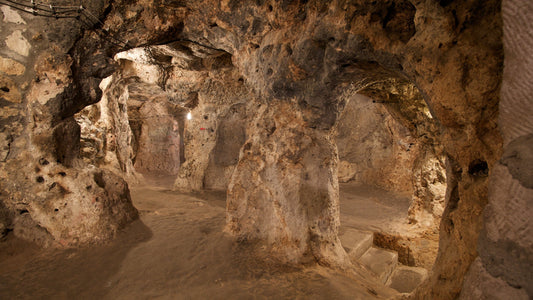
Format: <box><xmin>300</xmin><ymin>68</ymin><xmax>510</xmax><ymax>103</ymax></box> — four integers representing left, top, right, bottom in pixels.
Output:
<box><xmin>227</xmin><ymin>101</ymin><xmax>349</xmax><ymax>267</ymax></box>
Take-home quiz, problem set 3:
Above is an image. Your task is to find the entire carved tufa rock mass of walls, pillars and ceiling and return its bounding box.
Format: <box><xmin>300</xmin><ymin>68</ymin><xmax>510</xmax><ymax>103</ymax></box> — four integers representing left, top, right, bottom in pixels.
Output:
<box><xmin>0</xmin><ymin>0</ymin><xmax>533</xmax><ymax>299</ymax></box>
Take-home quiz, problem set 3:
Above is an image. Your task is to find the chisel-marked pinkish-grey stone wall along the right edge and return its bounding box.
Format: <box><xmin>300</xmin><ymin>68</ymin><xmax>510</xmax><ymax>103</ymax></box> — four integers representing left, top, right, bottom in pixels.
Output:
<box><xmin>461</xmin><ymin>1</ymin><xmax>533</xmax><ymax>299</ymax></box>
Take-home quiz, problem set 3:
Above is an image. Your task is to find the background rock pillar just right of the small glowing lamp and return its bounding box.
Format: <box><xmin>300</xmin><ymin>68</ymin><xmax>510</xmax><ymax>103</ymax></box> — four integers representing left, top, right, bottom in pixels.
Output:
<box><xmin>169</xmin><ymin>57</ymin><xmax>255</xmax><ymax>191</ymax></box>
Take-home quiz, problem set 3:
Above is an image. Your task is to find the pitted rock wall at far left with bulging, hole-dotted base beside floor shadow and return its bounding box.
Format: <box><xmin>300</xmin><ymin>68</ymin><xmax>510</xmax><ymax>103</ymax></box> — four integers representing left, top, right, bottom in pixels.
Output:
<box><xmin>0</xmin><ymin>1</ymin><xmax>137</xmax><ymax>247</ymax></box>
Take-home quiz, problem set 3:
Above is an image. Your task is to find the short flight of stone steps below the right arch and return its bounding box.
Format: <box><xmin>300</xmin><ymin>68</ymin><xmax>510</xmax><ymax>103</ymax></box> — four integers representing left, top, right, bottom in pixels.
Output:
<box><xmin>339</xmin><ymin>228</ymin><xmax>428</xmax><ymax>293</ymax></box>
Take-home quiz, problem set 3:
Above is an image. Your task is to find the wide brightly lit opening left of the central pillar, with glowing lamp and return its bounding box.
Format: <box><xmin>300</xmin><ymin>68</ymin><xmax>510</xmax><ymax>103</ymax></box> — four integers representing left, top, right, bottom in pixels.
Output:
<box><xmin>77</xmin><ymin>41</ymin><xmax>245</xmax><ymax>192</ymax></box>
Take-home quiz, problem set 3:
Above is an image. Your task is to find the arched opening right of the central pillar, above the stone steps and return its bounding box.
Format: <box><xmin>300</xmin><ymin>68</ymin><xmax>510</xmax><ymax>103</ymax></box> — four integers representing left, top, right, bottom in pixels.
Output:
<box><xmin>336</xmin><ymin>85</ymin><xmax>446</xmax><ymax>269</ymax></box>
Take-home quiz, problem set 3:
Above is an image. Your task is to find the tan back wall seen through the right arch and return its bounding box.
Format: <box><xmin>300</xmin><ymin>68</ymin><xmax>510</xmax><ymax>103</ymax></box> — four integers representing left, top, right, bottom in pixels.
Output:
<box><xmin>336</xmin><ymin>95</ymin><xmax>419</xmax><ymax>192</ymax></box>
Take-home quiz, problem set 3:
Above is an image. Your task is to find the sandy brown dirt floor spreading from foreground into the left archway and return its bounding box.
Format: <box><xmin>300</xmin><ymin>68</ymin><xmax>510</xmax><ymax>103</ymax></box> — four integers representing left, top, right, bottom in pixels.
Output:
<box><xmin>0</xmin><ymin>182</ymin><xmax>406</xmax><ymax>299</ymax></box>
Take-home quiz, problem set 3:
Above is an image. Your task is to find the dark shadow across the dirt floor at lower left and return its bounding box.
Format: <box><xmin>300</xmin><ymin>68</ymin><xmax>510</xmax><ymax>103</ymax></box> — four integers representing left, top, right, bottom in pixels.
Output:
<box><xmin>0</xmin><ymin>220</ymin><xmax>152</xmax><ymax>299</ymax></box>
